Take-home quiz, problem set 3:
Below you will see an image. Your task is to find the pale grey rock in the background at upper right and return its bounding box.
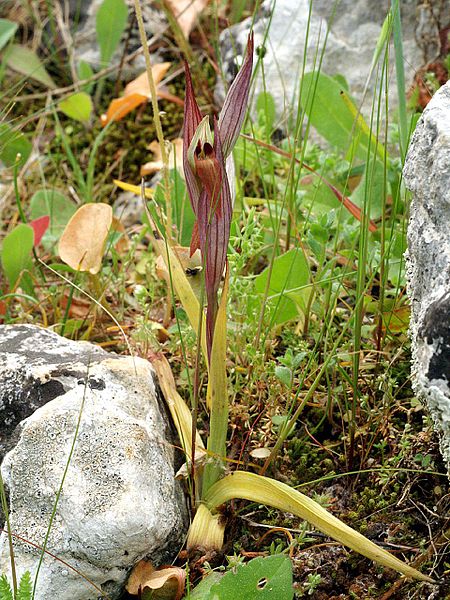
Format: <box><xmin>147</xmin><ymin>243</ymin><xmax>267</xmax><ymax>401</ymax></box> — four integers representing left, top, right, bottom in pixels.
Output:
<box><xmin>217</xmin><ymin>0</ymin><xmax>450</xmax><ymax>129</ymax></box>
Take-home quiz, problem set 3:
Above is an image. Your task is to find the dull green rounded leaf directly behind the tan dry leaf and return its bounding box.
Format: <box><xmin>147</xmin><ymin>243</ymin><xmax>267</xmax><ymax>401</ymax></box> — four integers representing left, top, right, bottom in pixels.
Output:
<box><xmin>30</xmin><ymin>188</ymin><xmax>77</xmax><ymax>250</ymax></box>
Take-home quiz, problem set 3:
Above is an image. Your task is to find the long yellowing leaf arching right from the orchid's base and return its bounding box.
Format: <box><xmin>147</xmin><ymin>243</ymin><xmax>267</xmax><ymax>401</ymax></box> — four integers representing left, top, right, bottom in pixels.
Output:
<box><xmin>204</xmin><ymin>471</ymin><xmax>433</xmax><ymax>582</ymax></box>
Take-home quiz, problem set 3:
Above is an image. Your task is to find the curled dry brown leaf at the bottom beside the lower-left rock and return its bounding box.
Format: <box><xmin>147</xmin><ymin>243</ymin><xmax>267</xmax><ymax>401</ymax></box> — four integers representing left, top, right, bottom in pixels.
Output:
<box><xmin>126</xmin><ymin>560</ymin><xmax>186</xmax><ymax>600</ymax></box>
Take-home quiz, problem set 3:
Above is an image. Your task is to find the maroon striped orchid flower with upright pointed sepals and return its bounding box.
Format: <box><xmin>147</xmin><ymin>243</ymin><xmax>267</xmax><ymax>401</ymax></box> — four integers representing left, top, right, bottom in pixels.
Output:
<box><xmin>183</xmin><ymin>33</ymin><xmax>253</xmax><ymax>358</ymax></box>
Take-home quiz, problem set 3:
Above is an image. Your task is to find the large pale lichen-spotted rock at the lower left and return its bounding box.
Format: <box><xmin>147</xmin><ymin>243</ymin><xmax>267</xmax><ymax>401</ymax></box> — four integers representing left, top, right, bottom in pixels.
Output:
<box><xmin>0</xmin><ymin>325</ymin><xmax>187</xmax><ymax>600</ymax></box>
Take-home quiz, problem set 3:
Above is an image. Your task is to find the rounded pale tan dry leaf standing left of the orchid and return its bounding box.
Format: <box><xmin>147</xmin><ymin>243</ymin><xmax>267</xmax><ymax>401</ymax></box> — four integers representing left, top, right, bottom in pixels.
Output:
<box><xmin>59</xmin><ymin>202</ymin><xmax>113</xmax><ymax>274</ymax></box>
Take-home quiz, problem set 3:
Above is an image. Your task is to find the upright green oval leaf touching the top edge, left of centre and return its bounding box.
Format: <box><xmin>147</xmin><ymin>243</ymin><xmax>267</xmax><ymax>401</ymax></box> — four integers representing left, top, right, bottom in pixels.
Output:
<box><xmin>96</xmin><ymin>0</ymin><xmax>128</xmax><ymax>66</ymax></box>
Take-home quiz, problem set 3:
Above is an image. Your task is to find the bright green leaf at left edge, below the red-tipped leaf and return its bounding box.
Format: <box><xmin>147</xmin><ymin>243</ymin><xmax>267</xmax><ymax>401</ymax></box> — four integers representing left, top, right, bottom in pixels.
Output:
<box><xmin>1</xmin><ymin>223</ymin><xmax>34</xmax><ymax>296</ymax></box>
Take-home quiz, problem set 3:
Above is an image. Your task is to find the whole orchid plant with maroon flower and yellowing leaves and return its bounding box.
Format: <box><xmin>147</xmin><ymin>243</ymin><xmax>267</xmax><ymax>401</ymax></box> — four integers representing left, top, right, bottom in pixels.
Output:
<box><xmin>147</xmin><ymin>34</ymin><xmax>432</xmax><ymax>581</ymax></box>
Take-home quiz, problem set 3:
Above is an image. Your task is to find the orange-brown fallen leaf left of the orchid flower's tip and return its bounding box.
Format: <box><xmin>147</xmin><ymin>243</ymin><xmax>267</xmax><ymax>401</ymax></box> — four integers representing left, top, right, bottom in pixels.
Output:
<box><xmin>101</xmin><ymin>62</ymin><xmax>183</xmax><ymax>126</ymax></box>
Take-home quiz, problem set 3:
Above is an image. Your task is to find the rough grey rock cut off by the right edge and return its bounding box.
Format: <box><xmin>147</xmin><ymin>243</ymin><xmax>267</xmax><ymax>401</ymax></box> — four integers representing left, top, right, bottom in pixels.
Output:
<box><xmin>403</xmin><ymin>82</ymin><xmax>450</xmax><ymax>471</ymax></box>
